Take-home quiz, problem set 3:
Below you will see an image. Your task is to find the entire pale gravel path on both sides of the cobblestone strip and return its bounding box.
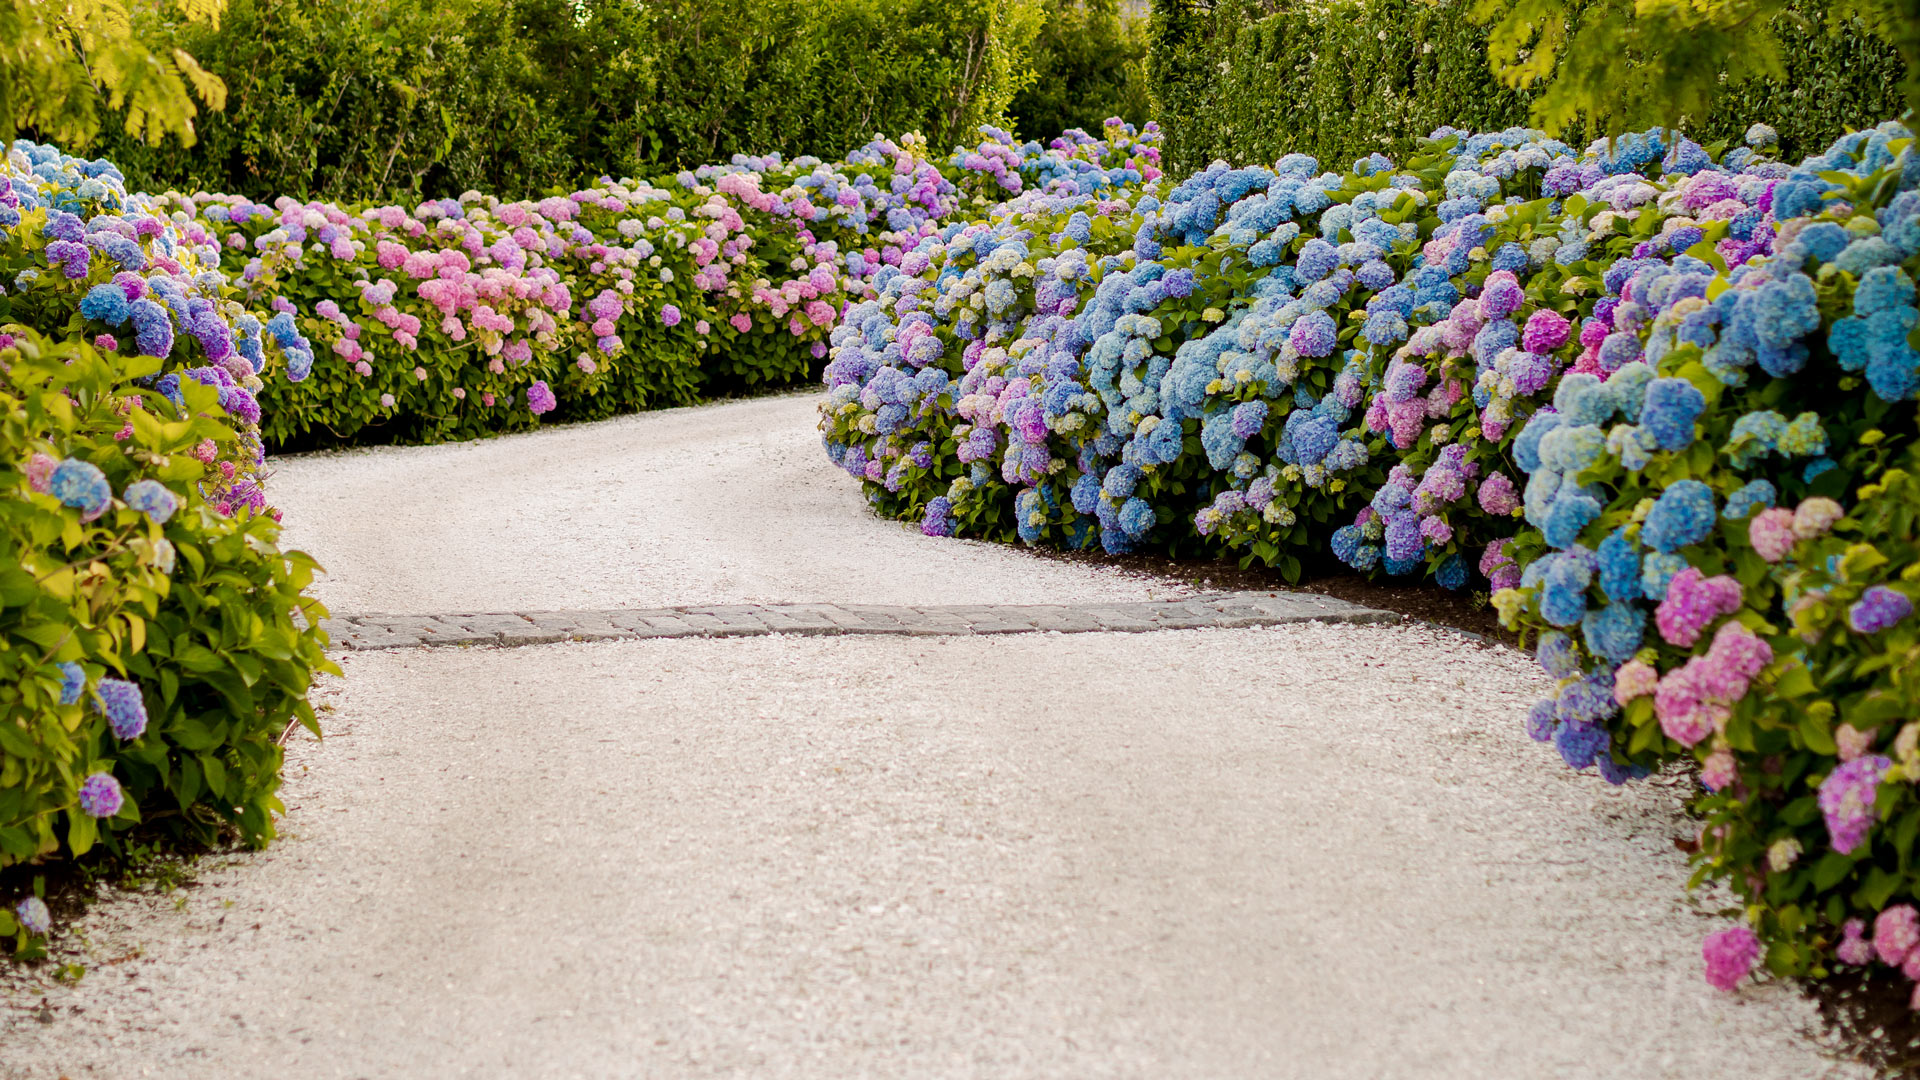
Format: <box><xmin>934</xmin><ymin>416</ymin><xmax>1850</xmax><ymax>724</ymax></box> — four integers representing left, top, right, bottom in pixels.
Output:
<box><xmin>0</xmin><ymin>390</ymin><xmax>1857</xmax><ymax>1080</ymax></box>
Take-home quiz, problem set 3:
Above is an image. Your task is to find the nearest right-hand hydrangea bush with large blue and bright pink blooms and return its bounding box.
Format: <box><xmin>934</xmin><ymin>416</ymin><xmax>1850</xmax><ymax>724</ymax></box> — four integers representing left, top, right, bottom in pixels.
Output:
<box><xmin>1496</xmin><ymin>125</ymin><xmax>1920</xmax><ymax>1003</ymax></box>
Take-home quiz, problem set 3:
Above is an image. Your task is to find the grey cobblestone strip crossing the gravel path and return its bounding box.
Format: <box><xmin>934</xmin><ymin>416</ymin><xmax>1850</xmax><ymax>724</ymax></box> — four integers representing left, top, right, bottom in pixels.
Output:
<box><xmin>324</xmin><ymin>592</ymin><xmax>1402</xmax><ymax>650</ymax></box>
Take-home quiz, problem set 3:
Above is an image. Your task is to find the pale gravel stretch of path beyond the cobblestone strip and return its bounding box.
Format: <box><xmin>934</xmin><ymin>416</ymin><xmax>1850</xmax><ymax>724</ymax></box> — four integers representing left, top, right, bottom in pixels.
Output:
<box><xmin>269</xmin><ymin>394</ymin><xmax>1185</xmax><ymax>615</ymax></box>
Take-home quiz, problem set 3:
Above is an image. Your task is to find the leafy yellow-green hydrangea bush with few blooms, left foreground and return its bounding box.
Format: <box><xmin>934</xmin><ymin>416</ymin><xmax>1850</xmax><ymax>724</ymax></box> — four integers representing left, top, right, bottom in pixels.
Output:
<box><xmin>0</xmin><ymin>331</ymin><xmax>330</xmax><ymax>951</ymax></box>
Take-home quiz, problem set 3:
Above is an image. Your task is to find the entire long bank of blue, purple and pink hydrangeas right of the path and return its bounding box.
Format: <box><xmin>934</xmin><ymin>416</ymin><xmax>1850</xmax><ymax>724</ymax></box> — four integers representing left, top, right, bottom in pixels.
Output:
<box><xmin>822</xmin><ymin>115</ymin><xmax>1920</xmax><ymax>986</ymax></box>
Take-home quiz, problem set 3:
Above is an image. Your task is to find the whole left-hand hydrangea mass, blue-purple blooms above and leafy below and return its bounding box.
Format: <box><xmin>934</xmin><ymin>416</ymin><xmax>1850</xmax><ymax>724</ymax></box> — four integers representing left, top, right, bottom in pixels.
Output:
<box><xmin>0</xmin><ymin>144</ymin><xmax>326</xmax><ymax>951</ymax></box>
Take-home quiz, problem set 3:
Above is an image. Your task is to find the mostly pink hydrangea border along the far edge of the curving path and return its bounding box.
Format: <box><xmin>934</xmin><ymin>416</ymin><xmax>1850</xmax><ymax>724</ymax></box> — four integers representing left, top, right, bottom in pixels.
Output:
<box><xmin>120</xmin><ymin>121</ymin><xmax>1160</xmax><ymax>446</ymax></box>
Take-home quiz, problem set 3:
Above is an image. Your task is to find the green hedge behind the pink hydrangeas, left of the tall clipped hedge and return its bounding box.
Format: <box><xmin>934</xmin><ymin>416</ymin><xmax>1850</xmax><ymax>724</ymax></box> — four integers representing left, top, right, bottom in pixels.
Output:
<box><xmin>88</xmin><ymin>0</ymin><xmax>1025</xmax><ymax>202</ymax></box>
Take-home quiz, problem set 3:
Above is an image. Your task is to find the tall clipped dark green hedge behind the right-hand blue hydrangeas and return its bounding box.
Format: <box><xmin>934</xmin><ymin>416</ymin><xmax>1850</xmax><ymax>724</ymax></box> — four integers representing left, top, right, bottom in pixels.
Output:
<box><xmin>1148</xmin><ymin>0</ymin><xmax>1907</xmax><ymax>177</ymax></box>
